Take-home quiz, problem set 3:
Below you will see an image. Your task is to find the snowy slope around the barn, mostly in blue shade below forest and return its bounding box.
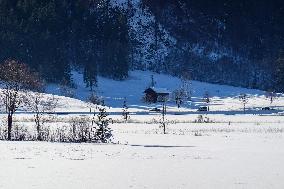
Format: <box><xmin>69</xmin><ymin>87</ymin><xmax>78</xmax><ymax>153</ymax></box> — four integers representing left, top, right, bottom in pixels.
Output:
<box><xmin>0</xmin><ymin>71</ymin><xmax>284</xmax><ymax>114</ymax></box>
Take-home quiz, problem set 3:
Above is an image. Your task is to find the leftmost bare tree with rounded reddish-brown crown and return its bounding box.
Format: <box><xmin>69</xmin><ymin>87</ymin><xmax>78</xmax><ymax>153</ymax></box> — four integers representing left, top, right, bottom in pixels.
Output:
<box><xmin>0</xmin><ymin>59</ymin><xmax>42</xmax><ymax>140</ymax></box>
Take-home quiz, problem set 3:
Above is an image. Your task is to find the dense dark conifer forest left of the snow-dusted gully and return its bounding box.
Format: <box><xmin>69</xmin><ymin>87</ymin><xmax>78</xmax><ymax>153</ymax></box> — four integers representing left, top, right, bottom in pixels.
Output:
<box><xmin>0</xmin><ymin>0</ymin><xmax>128</xmax><ymax>89</ymax></box>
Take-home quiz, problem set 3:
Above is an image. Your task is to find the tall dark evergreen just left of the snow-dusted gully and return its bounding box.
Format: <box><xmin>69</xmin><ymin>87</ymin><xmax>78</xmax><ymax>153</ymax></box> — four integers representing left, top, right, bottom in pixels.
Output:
<box><xmin>99</xmin><ymin>9</ymin><xmax>129</xmax><ymax>80</ymax></box>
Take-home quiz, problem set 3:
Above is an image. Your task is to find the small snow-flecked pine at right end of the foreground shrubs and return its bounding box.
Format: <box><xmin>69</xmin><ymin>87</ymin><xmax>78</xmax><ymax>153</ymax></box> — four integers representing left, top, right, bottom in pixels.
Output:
<box><xmin>95</xmin><ymin>107</ymin><xmax>112</xmax><ymax>143</ymax></box>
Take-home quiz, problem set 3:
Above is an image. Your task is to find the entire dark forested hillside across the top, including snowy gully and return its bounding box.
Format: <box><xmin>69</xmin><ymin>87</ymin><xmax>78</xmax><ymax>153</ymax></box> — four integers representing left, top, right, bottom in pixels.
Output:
<box><xmin>0</xmin><ymin>0</ymin><xmax>284</xmax><ymax>91</ymax></box>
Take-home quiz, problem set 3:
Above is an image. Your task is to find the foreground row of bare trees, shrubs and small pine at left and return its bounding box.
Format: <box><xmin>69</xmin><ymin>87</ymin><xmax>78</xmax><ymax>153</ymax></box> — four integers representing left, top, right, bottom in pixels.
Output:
<box><xmin>0</xmin><ymin>60</ymin><xmax>112</xmax><ymax>143</ymax></box>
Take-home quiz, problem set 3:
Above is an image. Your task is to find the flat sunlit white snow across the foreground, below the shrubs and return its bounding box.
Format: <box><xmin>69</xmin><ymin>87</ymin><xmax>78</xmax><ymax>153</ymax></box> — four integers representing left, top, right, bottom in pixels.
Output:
<box><xmin>0</xmin><ymin>123</ymin><xmax>284</xmax><ymax>189</ymax></box>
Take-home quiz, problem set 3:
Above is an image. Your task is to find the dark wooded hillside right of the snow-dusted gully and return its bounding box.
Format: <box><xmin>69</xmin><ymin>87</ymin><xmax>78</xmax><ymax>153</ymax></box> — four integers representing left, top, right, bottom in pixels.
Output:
<box><xmin>143</xmin><ymin>0</ymin><xmax>284</xmax><ymax>90</ymax></box>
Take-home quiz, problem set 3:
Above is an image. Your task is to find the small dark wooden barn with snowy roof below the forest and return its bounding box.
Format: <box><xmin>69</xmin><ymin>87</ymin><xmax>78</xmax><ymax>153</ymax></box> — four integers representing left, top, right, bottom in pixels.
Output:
<box><xmin>144</xmin><ymin>87</ymin><xmax>170</xmax><ymax>103</ymax></box>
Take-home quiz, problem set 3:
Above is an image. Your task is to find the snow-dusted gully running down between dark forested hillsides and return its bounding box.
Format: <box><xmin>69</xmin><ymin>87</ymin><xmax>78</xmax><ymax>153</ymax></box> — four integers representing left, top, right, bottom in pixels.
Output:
<box><xmin>111</xmin><ymin>0</ymin><xmax>176</xmax><ymax>70</ymax></box>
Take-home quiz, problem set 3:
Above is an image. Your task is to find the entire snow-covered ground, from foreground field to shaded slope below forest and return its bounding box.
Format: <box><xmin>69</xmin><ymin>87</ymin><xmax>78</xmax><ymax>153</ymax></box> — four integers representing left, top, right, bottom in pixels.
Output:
<box><xmin>0</xmin><ymin>71</ymin><xmax>284</xmax><ymax>189</ymax></box>
